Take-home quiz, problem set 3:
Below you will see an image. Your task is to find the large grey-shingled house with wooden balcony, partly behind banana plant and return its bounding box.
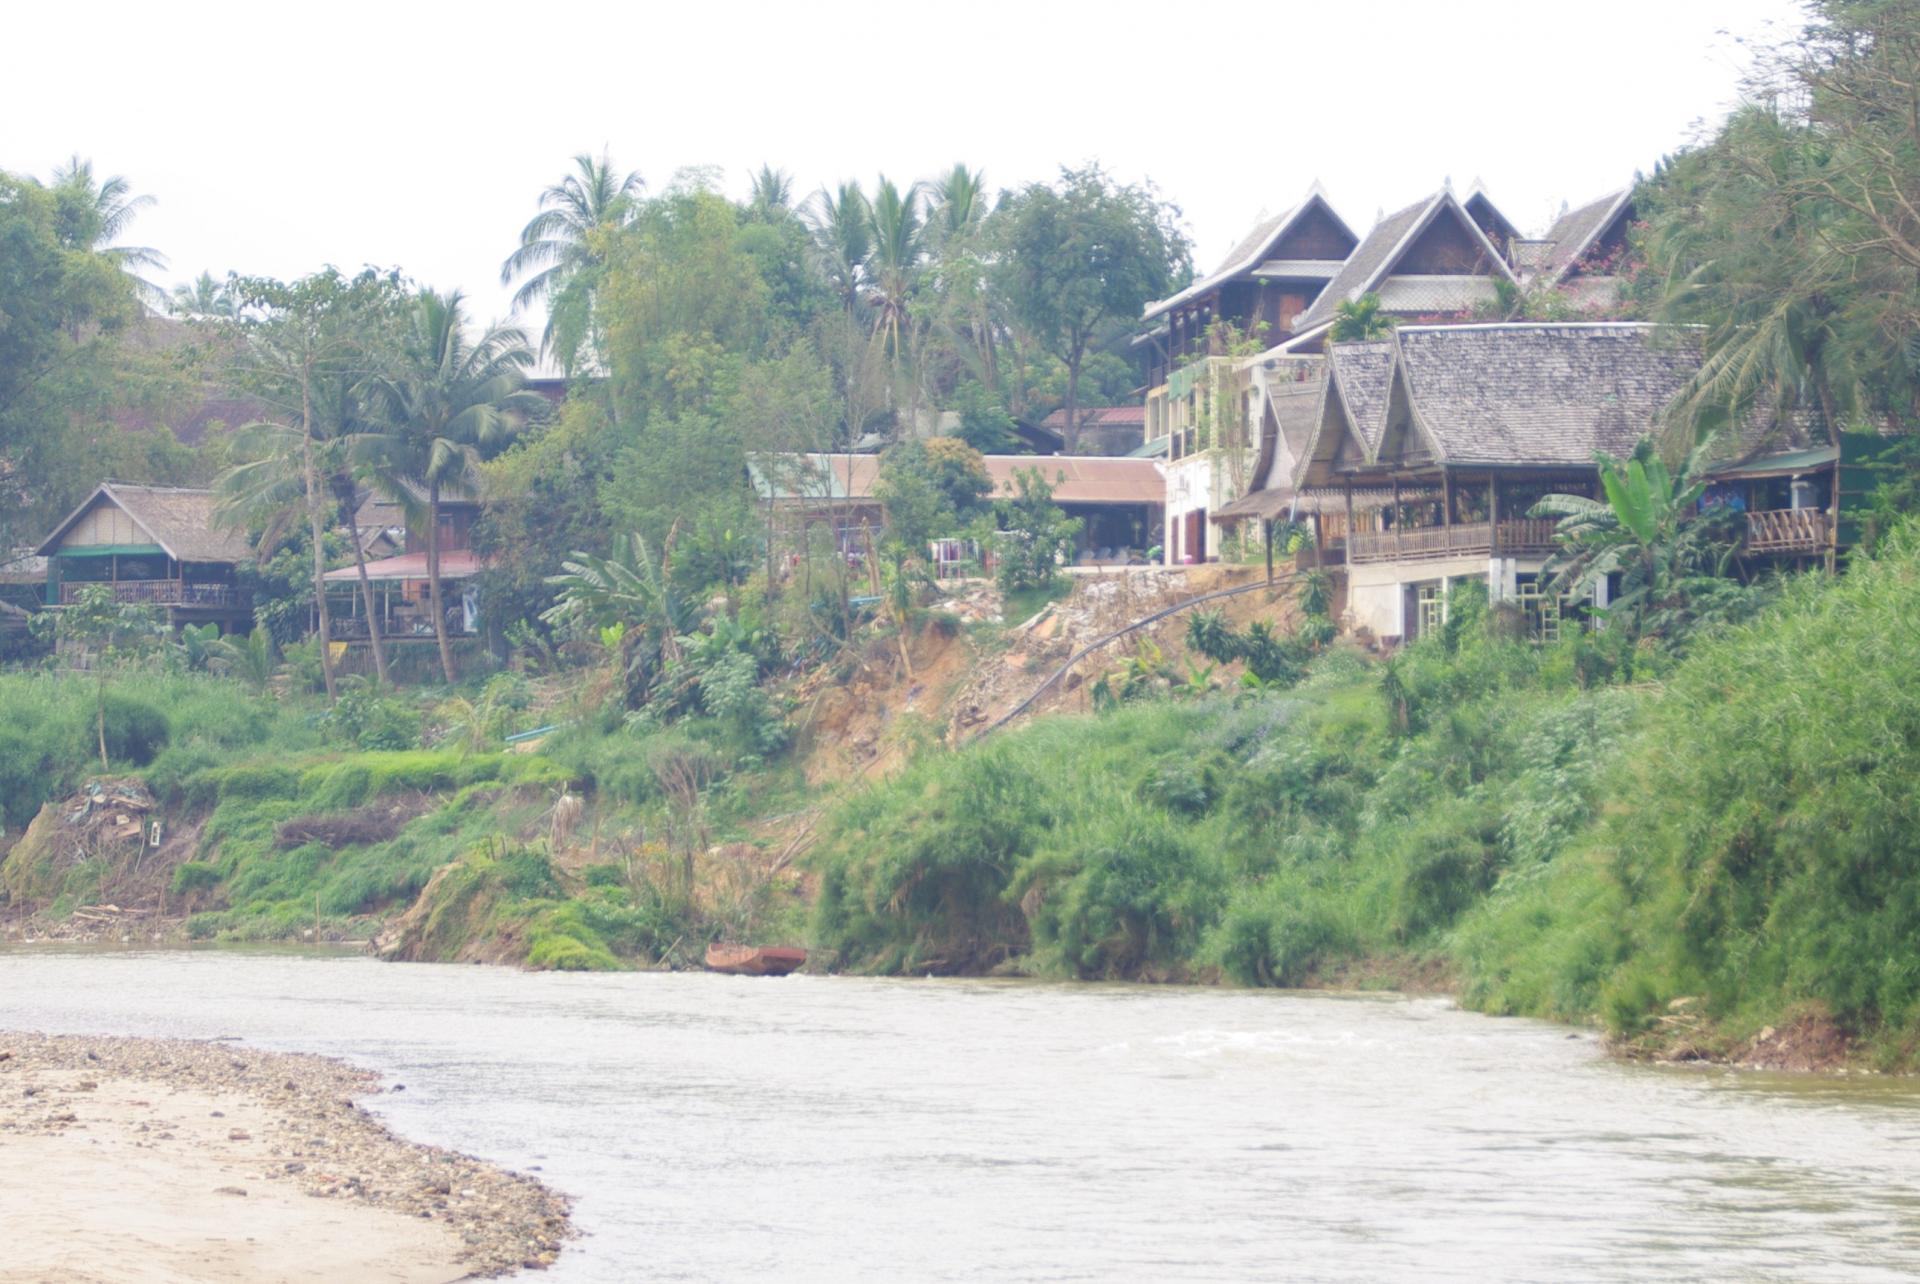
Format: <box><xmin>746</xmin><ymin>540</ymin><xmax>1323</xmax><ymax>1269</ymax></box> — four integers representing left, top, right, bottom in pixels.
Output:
<box><xmin>1275</xmin><ymin>322</ymin><xmax>1836</xmax><ymax>639</ymax></box>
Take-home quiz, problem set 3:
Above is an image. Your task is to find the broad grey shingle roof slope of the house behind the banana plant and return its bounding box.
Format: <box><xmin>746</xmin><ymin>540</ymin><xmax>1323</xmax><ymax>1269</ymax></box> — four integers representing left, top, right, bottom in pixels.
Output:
<box><xmin>1397</xmin><ymin>322</ymin><xmax>1699</xmax><ymax>466</ymax></box>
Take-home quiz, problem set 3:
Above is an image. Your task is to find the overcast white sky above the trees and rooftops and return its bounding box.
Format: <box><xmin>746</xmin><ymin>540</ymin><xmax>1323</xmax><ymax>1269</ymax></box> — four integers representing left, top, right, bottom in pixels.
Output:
<box><xmin>0</xmin><ymin>0</ymin><xmax>1799</xmax><ymax>339</ymax></box>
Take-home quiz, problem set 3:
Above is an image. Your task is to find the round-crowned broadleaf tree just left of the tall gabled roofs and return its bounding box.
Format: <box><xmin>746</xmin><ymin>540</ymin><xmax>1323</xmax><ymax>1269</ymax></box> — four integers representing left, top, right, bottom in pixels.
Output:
<box><xmin>996</xmin><ymin>167</ymin><xmax>1192</xmax><ymax>451</ymax></box>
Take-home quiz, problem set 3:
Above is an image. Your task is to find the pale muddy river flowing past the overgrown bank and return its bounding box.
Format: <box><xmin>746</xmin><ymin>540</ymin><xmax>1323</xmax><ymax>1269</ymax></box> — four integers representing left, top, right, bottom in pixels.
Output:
<box><xmin>0</xmin><ymin>948</ymin><xmax>1920</xmax><ymax>1284</ymax></box>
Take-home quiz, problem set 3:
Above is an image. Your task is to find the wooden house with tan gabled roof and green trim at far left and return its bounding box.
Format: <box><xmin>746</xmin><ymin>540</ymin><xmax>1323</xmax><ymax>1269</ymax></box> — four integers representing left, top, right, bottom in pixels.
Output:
<box><xmin>35</xmin><ymin>482</ymin><xmax>252</xmax><ymax>631</ymax></box>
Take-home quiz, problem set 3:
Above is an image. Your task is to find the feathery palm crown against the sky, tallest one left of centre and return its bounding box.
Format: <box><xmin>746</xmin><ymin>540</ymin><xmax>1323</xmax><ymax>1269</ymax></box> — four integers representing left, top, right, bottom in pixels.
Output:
<box><xmin>499</xmin><ymin>152</ymin><xmax>645</xmax><ymax>369</ymax></box>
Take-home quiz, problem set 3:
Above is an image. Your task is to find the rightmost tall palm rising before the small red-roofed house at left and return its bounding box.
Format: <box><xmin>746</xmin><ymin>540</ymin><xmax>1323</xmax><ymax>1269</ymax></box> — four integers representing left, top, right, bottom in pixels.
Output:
<box><xmin>380</xmin><ymin>290</ymin><xmax>545</xmax><ymax>685</ymax></box>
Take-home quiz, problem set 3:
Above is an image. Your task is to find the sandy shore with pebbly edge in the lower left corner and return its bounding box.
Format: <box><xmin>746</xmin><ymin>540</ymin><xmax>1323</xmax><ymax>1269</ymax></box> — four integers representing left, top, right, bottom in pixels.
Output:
<box><xmin>0</xmin><ymin>1033</ymin><xmax>572</xmax><ymax>1284</ymax></box>
